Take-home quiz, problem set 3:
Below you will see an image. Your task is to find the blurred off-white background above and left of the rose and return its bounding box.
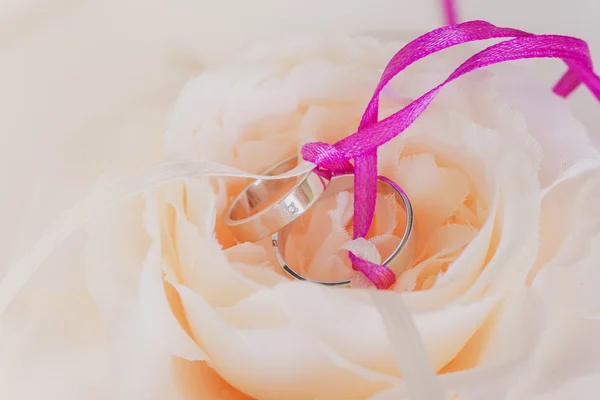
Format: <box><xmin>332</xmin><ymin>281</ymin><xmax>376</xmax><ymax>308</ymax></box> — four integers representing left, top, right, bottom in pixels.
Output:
<box><xmin>0</xmin><ymin>0</ymin><xmax>600</xmax><ymax>271</ymax></box>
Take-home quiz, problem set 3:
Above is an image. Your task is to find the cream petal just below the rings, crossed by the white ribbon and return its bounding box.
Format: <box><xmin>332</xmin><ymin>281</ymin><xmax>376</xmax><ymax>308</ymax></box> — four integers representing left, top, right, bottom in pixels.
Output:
<box><xmin>219</xmin><ymin>282</ymin><xmax>499</xmax><ymax>374</ymax></box>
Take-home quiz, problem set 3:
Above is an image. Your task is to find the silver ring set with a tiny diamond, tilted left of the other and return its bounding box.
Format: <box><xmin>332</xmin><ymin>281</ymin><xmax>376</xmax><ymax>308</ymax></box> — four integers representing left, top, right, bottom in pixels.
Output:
<box><xmin>225</xmin><ymin>156</ymin><xmax>329</xmax><ymax>242</ymax></box>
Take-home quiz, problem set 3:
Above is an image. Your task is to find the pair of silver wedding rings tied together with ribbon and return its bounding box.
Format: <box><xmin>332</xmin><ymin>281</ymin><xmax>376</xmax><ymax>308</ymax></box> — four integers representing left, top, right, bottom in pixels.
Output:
<box><xmin>226</xmin><ymin>156</ymin><xmax>414</xmax><ymax>286</ymax></box>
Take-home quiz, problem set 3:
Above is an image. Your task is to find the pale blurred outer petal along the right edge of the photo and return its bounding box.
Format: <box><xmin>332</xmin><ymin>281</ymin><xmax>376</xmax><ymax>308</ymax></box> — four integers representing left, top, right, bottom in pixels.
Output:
<box><xmin>504</xmin><ymin>170</ymin><xmax>600</xmax><ymax>399</ymax></box>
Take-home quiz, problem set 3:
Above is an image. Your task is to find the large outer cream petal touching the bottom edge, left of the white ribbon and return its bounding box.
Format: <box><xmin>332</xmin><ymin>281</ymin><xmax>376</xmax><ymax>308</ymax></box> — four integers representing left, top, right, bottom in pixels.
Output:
<box><xmin>176</xmin><ymin>285</ymin><xmax>397</xmax><ymax>400</ymax></box>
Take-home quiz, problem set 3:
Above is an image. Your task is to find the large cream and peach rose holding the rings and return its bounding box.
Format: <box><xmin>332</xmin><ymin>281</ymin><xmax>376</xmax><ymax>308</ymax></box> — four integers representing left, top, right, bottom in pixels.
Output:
<box><xmin>1</xmin><ymin>32</ymin><xmax>600</xmax><ymax>400</ymax></box>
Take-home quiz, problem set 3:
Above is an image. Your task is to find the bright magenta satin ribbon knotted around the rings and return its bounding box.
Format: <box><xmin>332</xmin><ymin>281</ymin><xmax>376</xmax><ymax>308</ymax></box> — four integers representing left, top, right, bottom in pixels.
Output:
<box><xmin>302</xmin><ymin>21</ymin><xmax>600</xmax><ymax>289</ymax></box>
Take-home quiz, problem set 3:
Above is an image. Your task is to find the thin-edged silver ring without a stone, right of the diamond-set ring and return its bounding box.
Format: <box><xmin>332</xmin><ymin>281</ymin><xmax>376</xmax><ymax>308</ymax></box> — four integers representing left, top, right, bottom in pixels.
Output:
<box><xmin>271</xmin><ymin>174</ymin><xmax>414</xmax><ymax>286</ymax></box>
